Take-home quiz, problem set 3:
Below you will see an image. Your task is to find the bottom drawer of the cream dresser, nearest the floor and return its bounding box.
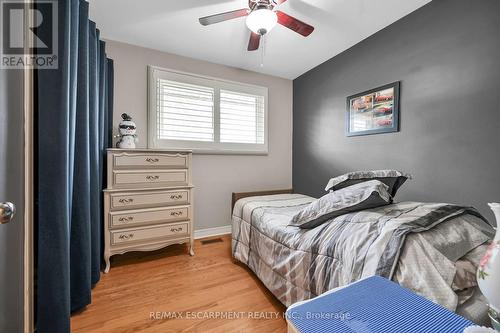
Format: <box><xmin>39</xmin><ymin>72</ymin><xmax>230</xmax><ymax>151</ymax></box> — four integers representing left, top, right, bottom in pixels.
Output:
<box><xmin>111</xmin><ymin>222</ymin><xmax>189</xmax><ymax>246</ymax></box>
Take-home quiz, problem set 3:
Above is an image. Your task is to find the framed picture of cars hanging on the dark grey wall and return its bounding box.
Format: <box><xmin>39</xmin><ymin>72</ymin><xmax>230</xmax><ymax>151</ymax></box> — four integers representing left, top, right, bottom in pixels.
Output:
<box><xmin>346</xmin><ymin>81</ymin><xmax>400</xmax><ymax>136</ymax></box>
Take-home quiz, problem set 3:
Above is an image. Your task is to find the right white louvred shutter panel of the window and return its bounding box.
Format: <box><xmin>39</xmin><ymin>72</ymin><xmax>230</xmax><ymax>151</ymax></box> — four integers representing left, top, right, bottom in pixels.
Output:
<box><xmin>220</xmin><ymin>90</ymin><xmax>264</xmax><ymax>144</ymax></box>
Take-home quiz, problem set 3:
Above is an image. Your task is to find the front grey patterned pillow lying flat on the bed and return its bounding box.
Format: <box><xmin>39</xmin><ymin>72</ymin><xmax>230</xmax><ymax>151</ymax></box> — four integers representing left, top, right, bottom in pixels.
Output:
<box><xmin>288</xmin><ymin>180</ymin><xmax>391</xmax><ymax>229</ymax></box>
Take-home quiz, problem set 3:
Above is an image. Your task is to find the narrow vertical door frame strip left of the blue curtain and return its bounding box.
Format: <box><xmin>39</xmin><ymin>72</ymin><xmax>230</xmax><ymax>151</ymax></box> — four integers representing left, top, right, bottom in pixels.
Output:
<box><xmin>22</xmin><ymin>0</ymin><xmax>35</xmax><ymax>333</ymax></box>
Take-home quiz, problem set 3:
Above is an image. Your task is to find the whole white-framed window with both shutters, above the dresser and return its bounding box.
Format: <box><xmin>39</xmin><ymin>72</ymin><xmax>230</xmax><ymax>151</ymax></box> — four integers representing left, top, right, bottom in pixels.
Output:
<box><xmin>149</xmin><ymin>67</ymin><xmax>267</xmax><ymax>154</ymax></box>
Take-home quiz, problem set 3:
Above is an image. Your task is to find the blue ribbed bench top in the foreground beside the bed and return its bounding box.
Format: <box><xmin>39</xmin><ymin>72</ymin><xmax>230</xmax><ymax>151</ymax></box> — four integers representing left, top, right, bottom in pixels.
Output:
<box><xmin>286</xmin><ymin>276</ymin><xmax>474</xmax><ymax>333</ymax></box>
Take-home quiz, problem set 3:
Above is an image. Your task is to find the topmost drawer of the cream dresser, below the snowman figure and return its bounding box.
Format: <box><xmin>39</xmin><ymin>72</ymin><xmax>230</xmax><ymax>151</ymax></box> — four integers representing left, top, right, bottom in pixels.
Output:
<box><xmin>112</xmin><ymin>153</ymin><xmax>188</xmax><ymax>169</ymax></box>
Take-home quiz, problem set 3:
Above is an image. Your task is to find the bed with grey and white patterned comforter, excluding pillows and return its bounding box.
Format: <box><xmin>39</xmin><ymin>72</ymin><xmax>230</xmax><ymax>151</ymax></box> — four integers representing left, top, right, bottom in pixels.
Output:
<box><xmin>232</xmin><ymin>190</ymin><xmax>493</xmax><ymax>325</ymax></box>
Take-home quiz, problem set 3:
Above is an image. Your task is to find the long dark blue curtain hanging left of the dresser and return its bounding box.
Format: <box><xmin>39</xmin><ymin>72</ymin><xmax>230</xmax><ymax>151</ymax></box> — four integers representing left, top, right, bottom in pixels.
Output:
<box><xmin>36</xmin><ymin>0</ymin><xmax>113</xmax><ymax>333</ymax></box>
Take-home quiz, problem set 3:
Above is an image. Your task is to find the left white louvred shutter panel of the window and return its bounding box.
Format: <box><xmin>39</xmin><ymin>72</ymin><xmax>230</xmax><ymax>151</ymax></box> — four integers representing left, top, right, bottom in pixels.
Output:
<box><xmin>156</xmin><ymin>79</ymin><xmax>215</xmax><ymax>141</ymax></box>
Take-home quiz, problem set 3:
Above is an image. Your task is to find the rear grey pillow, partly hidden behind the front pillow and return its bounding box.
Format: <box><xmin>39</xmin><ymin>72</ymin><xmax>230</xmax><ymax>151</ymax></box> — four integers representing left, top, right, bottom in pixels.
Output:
<box><xmin>325</xmin><ymin>170</ymin><xmax>411</xmax><ymax>198</ymax></box>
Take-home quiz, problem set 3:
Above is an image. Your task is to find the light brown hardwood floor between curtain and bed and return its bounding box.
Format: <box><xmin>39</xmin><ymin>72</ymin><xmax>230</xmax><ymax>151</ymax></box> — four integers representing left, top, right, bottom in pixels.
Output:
<box><xmin>71</xmin><ymin>235</ymin><xmax>286</xmax><ymax>333</ymax></box>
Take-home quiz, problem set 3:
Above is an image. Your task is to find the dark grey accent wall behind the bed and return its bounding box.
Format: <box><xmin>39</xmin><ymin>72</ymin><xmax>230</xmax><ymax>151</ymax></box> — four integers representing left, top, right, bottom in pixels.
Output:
<box><xmin>293</xmin><ymin>0</ymin><xmax>500</xmax><ymax>222</ymax></box>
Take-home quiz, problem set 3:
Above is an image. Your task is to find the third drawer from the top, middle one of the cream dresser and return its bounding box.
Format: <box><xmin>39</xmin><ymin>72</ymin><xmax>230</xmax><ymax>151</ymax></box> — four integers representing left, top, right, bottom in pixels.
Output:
<box><xmin>110</xmin><ymin>190</ymin><xmax>189</xmax><ymax>210</ymax></box>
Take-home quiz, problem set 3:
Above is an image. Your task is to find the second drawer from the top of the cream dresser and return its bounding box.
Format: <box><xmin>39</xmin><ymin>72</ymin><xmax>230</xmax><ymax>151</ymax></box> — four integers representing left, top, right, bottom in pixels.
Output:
<box><xmin>113</xmin><ymin>169</ymin><xmax>188</xmax><ymax>188</ymax></box>
